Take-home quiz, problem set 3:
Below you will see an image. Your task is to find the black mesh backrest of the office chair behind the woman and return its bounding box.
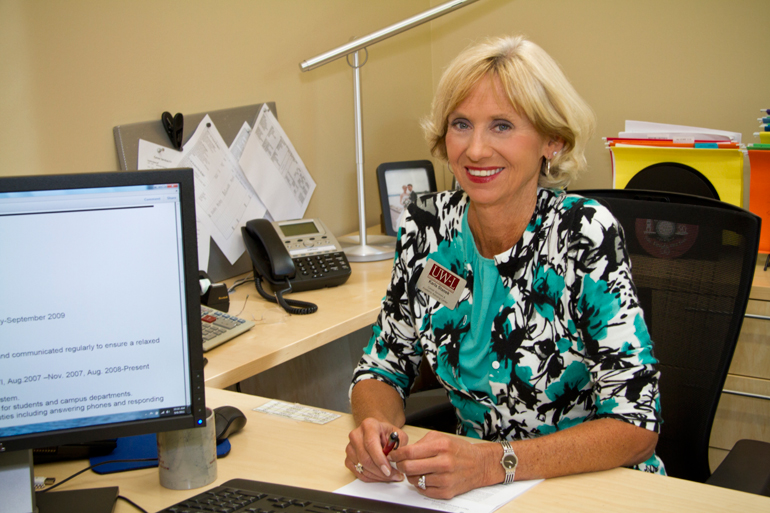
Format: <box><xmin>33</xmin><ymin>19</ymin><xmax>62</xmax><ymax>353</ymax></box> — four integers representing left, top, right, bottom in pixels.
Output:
<box><xmin>571</xmin><ymin>189</ymin><xmax>760</xmax><ymax>482</ymax></box>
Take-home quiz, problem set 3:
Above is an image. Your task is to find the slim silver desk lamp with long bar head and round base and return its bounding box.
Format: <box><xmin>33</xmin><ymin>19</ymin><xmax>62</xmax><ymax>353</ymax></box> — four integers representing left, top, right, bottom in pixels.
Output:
<box><xmin>299</xmin><ymin>0</ymin><xmax>477</xmax><ymax>262</ymax></box>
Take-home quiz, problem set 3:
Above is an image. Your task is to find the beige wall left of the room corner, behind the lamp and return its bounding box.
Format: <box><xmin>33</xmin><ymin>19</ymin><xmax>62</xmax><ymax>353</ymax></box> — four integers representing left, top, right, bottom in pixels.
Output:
<box><xmin>0</xmin><ymin>0</ymin><xmax>432</xmax><ymax>234</ymax></box>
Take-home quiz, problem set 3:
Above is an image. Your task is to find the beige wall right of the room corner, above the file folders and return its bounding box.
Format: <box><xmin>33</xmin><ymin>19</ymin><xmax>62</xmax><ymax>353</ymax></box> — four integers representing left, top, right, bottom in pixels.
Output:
<box><xmin>431</xmin><ymin>0</ymin><xmax>770</xmax><ymax>188</ymax></box>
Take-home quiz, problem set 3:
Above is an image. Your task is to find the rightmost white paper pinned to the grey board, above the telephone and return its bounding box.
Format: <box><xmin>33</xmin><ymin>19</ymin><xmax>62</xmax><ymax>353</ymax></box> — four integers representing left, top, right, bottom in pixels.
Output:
<box><xmin>239</xmin><ymin>105</ymin><xmax>315</xmax><ymax>221</ymax></box>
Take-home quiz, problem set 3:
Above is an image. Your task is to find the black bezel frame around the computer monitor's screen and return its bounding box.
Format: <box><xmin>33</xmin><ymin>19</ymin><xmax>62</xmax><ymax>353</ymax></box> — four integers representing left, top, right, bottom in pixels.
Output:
<box><xmin>0</xmin><ymin>168</ymin><xmax>206</xmax><ymax>452</ymax></box>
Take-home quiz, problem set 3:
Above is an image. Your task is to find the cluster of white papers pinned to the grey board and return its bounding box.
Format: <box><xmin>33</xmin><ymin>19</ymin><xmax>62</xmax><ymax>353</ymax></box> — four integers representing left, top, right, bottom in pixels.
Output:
<box><xmin>137</xmin><ymin>109</ymin><xmax>316</xmax><ymax>270</ymax></box>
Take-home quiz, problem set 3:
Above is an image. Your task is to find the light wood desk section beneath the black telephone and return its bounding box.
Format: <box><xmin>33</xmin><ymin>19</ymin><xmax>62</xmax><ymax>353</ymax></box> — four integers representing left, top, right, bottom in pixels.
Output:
<box><xmin>205</xmin><ymin>260</ymin><xmax>393</xmax><ymax>388</ymax></box>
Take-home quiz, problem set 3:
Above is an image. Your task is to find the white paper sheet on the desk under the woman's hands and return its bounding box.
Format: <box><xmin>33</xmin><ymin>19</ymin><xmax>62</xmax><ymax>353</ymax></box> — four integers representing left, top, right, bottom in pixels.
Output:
<box><xmin>334</xmin><ymin>479</ymin><xmax>543</xmax><ymax>513</ymax></box>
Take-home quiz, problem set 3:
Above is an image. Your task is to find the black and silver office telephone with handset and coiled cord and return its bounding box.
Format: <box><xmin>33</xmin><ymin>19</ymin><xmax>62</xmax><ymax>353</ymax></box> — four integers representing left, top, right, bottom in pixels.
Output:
<box><xmin>241</xmin><ymin>219</ymin><xmax>350</xmax><ymax>314</ymax></box>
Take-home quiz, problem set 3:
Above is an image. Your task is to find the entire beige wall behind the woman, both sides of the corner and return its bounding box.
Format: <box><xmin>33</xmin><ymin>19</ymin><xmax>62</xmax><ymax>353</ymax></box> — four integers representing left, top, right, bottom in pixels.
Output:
<box><xmin>0</xmin><ymin>0</ymin><xmax>770</xmax><ymax>234</ymax></box>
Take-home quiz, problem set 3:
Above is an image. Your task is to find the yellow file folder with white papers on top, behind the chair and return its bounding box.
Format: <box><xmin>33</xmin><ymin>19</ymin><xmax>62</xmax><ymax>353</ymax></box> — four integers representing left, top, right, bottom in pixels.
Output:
<box><xmin>606</xmin><ymin>121</ymin><xmax>743</xmax><ymax>206</ymax></box>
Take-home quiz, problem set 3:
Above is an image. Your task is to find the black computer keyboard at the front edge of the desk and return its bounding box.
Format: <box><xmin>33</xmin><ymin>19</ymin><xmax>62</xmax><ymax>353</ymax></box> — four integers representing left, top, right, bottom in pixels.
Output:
<box><xmin>159</xmin><ymin>479</ymin><xmax>435</xmax><ymax>513</ymax></box>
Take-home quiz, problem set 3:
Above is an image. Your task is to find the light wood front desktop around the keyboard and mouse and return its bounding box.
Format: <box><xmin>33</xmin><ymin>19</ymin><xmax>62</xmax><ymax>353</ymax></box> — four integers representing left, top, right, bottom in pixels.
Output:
<box><xmin>35</xmin><ymin>389</ymin><xmax>770</xmax><ymax>513</ymax></box>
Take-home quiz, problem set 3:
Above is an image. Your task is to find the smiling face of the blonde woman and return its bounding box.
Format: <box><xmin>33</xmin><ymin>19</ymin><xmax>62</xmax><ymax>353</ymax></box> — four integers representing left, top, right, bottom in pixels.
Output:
<box><xmin>446</xmin><ymin>77</ymin><xmax>562</xmax><ymax>212</ymax></box>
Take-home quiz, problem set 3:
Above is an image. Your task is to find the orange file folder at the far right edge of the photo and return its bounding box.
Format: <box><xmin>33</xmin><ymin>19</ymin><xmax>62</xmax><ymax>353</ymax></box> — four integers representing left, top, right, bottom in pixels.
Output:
<box><xmin>747</xmin><ymin>109</ymin><xmax>770</xmax><ymax>253</ymax></box>
